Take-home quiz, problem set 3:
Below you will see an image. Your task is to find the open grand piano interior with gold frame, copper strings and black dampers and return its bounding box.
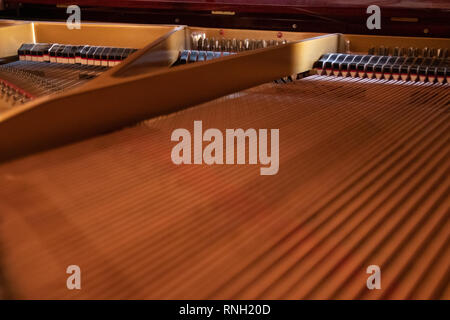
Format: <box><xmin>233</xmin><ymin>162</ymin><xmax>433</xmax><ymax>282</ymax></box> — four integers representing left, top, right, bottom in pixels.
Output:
<box><xmin>0</xmin><ymin>1</ymin><xmax>450</xmax><ymax>299</ymax></box>
